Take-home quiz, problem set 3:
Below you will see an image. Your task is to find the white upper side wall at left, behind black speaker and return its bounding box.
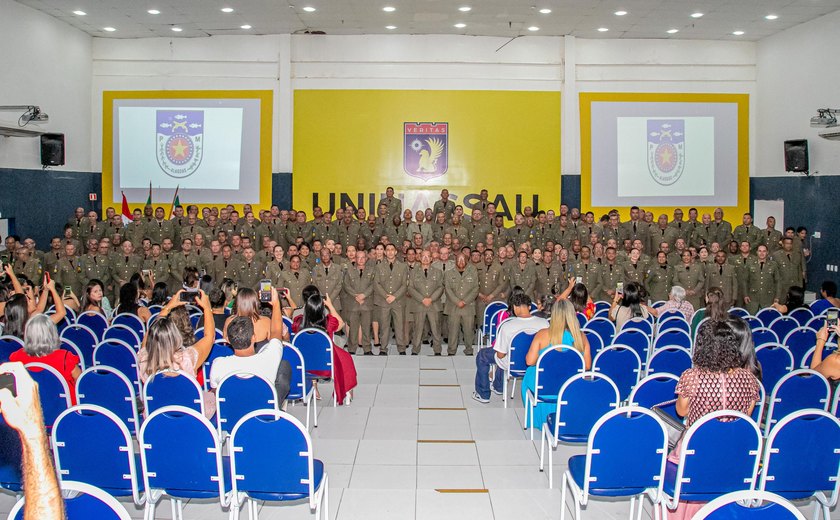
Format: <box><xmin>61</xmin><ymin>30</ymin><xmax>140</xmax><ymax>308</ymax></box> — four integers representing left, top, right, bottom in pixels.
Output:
<box><xmin>0</xmin><ymin>0</ymin><xmax>92</xmax><ymax>171</ymax></box>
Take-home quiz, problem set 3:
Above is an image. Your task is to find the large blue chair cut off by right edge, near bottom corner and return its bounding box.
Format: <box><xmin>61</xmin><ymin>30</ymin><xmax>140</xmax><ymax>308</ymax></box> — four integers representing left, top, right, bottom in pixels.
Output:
<box><xmin>759</xmin><ymin>410</ymin><xmax>840</xmax><ymax>520</ymax></box>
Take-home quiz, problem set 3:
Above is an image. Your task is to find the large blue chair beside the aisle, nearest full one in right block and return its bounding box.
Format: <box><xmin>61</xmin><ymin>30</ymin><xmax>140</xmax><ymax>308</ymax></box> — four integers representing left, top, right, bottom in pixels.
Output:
<box><xmin>560</xmin><ymin>406</ymin><xmax>668</xmax><ymax>520</ymax></box>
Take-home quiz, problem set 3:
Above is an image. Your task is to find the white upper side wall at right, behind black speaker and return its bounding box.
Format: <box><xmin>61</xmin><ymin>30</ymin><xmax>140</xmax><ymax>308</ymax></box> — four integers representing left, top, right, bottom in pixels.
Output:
<box><xmin>756</xmin><ymin>11</ymin><xmax>840</xmax><ymax>177</ymax></box>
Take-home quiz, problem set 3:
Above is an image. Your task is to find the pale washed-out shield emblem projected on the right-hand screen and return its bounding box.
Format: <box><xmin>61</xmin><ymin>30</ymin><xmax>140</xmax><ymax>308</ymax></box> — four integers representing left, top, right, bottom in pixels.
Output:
<box><xmin>647</xmin><ymin>119</ymin><xmax>685</xmax><ymax>186</ymax></box>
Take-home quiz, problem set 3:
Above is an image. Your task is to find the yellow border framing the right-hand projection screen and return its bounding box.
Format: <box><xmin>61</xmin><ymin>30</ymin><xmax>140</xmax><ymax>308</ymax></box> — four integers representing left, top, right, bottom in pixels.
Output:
<box><xmin>580</xmin><ymin>92</ymin><xmax>750</xmax><ymax>223</ymax></box>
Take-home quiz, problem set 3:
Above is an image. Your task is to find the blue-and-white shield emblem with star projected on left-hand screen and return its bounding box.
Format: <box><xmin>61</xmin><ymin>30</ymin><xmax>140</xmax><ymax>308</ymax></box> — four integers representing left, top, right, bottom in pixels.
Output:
<box><xmin>157</xmin><ymin>110</ymin><xmax>204</xmax><ymax>179</ymax></box>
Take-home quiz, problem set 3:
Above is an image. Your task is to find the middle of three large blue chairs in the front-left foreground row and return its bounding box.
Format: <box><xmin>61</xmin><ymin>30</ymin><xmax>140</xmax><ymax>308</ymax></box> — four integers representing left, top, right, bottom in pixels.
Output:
<box><xmin>138</xmin><ymin>406</ymin><xmax>231</xmax><ymax>520</ymax></box>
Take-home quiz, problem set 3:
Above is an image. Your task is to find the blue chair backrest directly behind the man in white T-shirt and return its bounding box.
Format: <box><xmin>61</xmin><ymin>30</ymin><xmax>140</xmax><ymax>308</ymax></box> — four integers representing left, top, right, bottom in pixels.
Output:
<box><xmin>216</xmin><ymin>372</ymin><xmax>278</xmax><ymax>438</ymax></box>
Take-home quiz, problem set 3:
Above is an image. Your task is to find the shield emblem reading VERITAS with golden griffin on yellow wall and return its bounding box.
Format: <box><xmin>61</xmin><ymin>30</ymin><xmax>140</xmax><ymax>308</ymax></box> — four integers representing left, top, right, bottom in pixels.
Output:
<box><xmin>403</xmin><ymin>123</ymin><xmax>449</xmax><ymax>181</ymax></box>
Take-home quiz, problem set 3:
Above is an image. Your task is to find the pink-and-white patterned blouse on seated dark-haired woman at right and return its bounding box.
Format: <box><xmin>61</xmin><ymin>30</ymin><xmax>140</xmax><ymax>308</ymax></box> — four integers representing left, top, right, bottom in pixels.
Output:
<box><xmin>676</xmin><ymin>368</ymin><xmax>760</xmax><ymax>428</ymax></box>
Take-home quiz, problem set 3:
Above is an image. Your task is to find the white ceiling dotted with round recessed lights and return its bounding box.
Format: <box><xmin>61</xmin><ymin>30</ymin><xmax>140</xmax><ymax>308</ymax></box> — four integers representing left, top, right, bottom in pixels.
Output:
<box><xmin>18</xmin><ymin>0</ymin><xmax>840</xmax><ymax>41</ymax></box>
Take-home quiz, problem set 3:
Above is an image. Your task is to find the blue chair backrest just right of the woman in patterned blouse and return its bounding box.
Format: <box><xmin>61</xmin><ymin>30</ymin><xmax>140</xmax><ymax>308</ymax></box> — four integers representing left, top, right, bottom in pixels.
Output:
<box><xmin>764</xmin><ymin>368</ymin><xmax>831</xmax><ymax>436</ymax></box>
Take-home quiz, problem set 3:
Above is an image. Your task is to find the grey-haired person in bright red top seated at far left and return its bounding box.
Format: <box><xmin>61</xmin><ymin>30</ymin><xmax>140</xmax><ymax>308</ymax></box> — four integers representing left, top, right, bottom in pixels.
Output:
<box><xmin>9</xmin><ymin>314</ymin><xmax>82</xmax><ymax>405</ymax></box>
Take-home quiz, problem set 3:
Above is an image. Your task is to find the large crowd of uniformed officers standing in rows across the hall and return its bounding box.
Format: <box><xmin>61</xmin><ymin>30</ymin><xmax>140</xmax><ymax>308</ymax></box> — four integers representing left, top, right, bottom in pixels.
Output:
<box><xmin>0</xmin><ymin>188</ymin><xmax>809</xmax><ymax>355</ymax></box>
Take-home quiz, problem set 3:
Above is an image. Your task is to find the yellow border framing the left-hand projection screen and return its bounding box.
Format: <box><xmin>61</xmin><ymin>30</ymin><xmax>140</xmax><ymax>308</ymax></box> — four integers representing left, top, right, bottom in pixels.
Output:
<box><xmin>102</xmin><ymin>90</ymin><xmax>274</xmax><ymax>215</ymax></box>
